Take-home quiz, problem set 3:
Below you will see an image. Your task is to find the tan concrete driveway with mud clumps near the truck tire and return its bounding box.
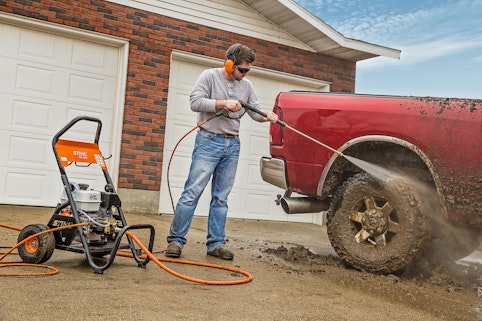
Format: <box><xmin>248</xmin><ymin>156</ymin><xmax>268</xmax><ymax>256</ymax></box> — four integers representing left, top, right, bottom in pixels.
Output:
<box><xmin>0</xmin><ymin>205</ymin><xmax>481</xmax><ymax>321</ymax></box>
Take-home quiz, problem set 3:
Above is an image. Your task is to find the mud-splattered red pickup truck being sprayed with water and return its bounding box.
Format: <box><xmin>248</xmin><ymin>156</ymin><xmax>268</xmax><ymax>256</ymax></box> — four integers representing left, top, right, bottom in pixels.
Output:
<box><xmin>260</xmin><ymin>92</ymin><xmax>482</xmax><ymax>273</ymax></box>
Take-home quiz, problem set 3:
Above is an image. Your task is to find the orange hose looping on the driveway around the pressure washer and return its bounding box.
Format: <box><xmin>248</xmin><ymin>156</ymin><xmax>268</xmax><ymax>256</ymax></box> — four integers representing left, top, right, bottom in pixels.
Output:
<box><xmin>0</xmin><ymin>223</ymin><xmax>253</xmax><ymax>285</ymax></box>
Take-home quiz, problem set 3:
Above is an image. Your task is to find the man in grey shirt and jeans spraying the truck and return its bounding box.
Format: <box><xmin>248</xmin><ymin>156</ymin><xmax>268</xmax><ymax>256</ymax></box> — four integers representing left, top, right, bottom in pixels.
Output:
<box><xmin>165</xmin><ymin>44</ymin><xmax>278</xmax><ymax>260</ymax></box>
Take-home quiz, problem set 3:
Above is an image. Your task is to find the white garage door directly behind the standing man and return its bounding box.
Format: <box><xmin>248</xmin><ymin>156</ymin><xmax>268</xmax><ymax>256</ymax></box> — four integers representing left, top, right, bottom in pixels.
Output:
<box><xmin>159</xmin><ymin>53</ymin><xmax>329</xmax><ymax>223</ymax></box>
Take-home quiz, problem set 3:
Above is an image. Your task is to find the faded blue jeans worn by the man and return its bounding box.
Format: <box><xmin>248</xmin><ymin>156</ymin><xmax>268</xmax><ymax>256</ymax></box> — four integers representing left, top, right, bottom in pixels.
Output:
<box><xmin>167</xmin><ymin>131</ymin><xmax>240</xmax><ymax>251</ymax></box>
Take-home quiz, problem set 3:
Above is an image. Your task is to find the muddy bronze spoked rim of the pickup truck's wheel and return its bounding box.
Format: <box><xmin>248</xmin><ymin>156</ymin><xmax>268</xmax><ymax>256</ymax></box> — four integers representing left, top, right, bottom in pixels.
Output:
<box><xmin>350</xmin><ymin>196</ymin><xmax>398</xmax><ymax>246</ymax></box>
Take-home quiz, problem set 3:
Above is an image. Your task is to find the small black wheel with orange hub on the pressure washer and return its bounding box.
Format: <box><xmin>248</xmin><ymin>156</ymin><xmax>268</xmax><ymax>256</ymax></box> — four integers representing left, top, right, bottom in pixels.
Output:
<box><xmin>17</xmin><ymin>224</ymin><xmax>55</xmax><ymax>264</ymax></box>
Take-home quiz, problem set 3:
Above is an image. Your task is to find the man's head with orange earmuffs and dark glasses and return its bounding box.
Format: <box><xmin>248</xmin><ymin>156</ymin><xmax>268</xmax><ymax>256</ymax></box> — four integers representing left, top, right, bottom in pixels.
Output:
<box><xmin>224</xmin><ymin>43</ymin><xmax>256</xmax><ymax>79</ymax></box>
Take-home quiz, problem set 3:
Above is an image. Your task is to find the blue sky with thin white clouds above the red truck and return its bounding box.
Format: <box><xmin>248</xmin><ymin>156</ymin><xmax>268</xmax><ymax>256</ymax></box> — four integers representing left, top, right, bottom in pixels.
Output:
<box><xmin>295</xmin><ymin>0</ymin><xmax>482</xmax><ymax>99</ymax></box>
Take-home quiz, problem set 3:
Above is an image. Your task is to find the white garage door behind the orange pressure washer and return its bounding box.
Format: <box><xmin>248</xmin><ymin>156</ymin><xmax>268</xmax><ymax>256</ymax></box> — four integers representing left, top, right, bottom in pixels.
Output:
<box><xmin>0</xmin><ymin>20</ymin><xmax>126</xmax><ymax>206</ymax></box>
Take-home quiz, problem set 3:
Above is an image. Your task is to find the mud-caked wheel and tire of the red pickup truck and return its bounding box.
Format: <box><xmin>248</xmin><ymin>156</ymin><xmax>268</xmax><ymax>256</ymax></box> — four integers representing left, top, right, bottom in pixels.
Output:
<box><xmin>327</xmin><ymin>173</ymin><xmax>430</xmax><ymax>274</ymax></box>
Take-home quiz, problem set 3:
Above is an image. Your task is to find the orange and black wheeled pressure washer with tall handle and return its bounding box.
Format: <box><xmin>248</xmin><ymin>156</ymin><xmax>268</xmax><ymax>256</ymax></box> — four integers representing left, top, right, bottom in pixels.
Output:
<box><xmin>18</xmin><ymin>116</ymin><xmax>155</xmax><ymax>274</ymax></box>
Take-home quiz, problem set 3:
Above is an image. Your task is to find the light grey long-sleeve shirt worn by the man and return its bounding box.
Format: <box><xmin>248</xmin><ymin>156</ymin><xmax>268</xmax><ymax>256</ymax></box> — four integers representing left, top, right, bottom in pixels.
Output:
<box><xmin>190</xmin><ymin>68</ymin><xmax>263</xmax><ymax>135</ymax></box>
